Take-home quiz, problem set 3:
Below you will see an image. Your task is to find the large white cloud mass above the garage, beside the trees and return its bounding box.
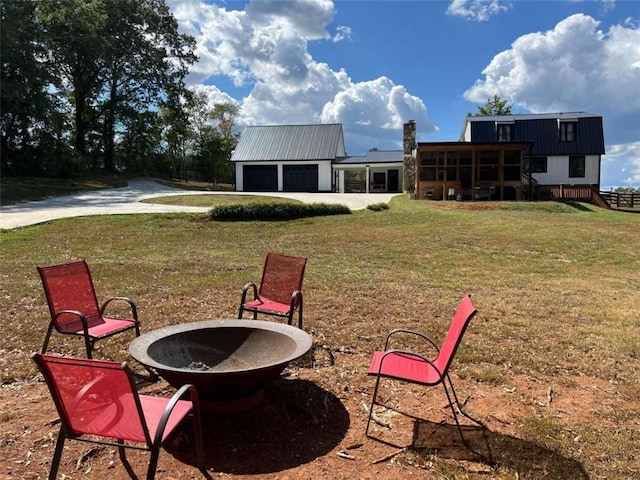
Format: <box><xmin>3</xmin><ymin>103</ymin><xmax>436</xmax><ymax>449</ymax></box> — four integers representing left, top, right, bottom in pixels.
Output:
<box><xmin>169</xmin><ymin>0</ymin><xmax>436</xmax><ymax>154</ymax></box>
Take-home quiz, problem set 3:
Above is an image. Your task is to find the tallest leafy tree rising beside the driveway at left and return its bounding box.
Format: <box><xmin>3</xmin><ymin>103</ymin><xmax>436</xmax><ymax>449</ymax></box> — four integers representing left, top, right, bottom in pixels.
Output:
<box><xmin>36</xmin><ymin>0</ymin><xmax>196</xmax><ymax>171</ymax></box>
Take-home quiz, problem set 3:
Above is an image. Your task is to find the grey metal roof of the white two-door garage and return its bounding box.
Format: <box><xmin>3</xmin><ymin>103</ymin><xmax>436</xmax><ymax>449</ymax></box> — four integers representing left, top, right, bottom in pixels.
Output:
<box><xmin>231</xmin><ymin>123</ymin><xmax>345</xmax><ymax>162</ymax></box>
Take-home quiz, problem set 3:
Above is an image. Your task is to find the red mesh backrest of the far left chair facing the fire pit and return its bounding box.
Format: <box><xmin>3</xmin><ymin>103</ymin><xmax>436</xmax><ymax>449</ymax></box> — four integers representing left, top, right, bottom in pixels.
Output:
<box><xmin>38</xmin><ymin>260</ymin><xmax>100</xmax><ymax>331</ymax></box>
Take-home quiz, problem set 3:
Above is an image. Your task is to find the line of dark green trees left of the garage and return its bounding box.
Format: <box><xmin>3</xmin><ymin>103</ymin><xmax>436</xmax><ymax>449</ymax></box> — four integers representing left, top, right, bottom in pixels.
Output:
<box><xmin>0</xmin><ymin>0</ymin><xmax>238</xmax><ymax>183</ymax></box>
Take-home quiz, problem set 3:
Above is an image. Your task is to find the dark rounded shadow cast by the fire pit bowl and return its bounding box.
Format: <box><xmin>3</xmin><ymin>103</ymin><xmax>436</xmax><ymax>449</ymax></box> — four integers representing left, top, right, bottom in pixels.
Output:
<box><xmin>167</xmin><ymin>379</ymin><xmax>350</xmax><ymax>475</ymax></box>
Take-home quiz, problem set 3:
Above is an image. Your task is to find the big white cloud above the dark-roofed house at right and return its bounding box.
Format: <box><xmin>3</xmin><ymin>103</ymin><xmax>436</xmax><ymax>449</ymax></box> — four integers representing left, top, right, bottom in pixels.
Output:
<box><xmin>464</xmin><ymin>14</ymin><xmax>640</xmax><ymax>144</ymax></box>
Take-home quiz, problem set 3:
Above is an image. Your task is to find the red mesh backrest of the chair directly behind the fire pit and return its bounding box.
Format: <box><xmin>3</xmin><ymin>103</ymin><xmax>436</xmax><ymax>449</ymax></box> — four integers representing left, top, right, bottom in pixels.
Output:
<box><xmin>258</xmin><ymin>252</ymin><xmax>307</xmax><ymax>303</ymax></box>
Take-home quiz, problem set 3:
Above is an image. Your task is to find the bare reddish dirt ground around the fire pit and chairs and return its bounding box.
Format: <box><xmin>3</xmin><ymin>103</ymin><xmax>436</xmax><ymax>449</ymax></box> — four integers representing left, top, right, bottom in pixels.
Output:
<box><xmin>0</xmin><ymin>347</ymin><xmax>640</xmax><ymax>480</ymax></box>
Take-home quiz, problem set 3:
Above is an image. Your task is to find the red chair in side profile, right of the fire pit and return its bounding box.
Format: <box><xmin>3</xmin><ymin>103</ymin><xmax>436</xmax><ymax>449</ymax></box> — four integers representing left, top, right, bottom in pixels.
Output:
<box><xmin>365</xmin><ymin>295</ymin><xmax>481</xmax><ymax>445</ymax></box>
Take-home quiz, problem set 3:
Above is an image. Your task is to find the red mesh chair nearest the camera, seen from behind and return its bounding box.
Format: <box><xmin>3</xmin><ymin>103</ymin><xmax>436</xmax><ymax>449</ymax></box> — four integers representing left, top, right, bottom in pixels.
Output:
<box><xmin>31</xmin><ymin>353</ymin><xmax>204</xmax><ymax>480</ymax></box>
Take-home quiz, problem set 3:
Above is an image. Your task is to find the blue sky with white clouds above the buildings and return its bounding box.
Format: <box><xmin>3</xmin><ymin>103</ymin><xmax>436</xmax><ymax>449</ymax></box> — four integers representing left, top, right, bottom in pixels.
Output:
<box><xmin>167</xmin><ymin>0</ymin><xmax>640</xmax><ymax>188</ymax></box>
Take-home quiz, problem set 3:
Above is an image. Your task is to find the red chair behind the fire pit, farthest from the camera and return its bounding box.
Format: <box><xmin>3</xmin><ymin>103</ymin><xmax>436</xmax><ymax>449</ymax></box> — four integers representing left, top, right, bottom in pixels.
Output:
<box><xmin>238</xmin><ymin>252</ymin><xmax>307</xmax><ymax>328</ymax></box>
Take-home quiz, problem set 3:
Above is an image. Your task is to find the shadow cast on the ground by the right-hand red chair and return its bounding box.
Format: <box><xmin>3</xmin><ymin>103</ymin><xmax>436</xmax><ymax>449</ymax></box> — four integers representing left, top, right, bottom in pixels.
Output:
<box><xmin>412</xmin><ymin>420</ymin><xmax>589</xmax><ymax>480</ymax></box>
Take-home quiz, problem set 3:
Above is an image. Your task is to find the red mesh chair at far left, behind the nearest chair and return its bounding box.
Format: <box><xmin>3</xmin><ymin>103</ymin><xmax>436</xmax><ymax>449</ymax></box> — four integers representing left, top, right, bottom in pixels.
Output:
<box><xmin>37</xmin><ymin>260</ymin><xmax>140</xmax><ymax>358</ymax></box>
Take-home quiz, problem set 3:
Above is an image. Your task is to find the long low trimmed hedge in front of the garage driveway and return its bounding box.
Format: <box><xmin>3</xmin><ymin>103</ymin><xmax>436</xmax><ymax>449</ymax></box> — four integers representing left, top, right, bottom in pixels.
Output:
<box><xmin>211</xmin><ymin>202</ymin><xmax>351</xmax><ymax>221</ymax></box>
